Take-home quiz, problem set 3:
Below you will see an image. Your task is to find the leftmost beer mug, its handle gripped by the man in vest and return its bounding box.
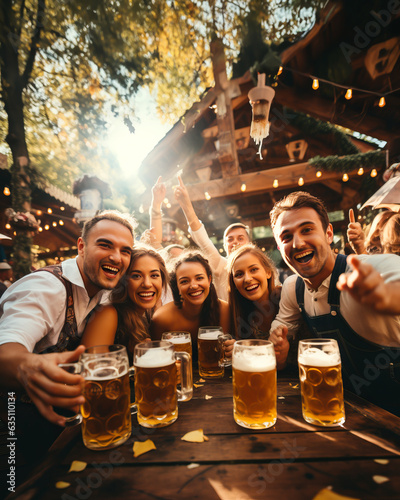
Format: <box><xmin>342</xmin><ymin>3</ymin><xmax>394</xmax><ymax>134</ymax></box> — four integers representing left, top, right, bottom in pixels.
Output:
<box><xmin>59</xmin><ymin>345</ymin><xmax>132</xmax><ymax>450</ymax></box>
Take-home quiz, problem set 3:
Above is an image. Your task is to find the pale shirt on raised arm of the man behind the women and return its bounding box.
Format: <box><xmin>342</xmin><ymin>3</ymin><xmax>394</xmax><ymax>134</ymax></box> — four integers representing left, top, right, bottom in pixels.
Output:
<box><xmin>189</xmin><ymin>224</ymin><xmax>229</xmax><ymax>301</ymax></box>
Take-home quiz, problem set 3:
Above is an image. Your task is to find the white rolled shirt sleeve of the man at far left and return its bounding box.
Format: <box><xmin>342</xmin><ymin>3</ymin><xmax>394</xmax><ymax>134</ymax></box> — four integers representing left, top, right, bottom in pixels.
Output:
<box><xmin>0</xmin><ymin>272</ymin><xmax>67</xmax><ymax>352</ymax></box>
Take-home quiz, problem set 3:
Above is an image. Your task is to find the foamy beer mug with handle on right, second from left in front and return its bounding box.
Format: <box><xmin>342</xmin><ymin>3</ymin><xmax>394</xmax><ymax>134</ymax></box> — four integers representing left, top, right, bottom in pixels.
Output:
<box><xmin>133</xmin><ymin>340</ymin><xmax>193</xmax><ymax>427</ymax></box>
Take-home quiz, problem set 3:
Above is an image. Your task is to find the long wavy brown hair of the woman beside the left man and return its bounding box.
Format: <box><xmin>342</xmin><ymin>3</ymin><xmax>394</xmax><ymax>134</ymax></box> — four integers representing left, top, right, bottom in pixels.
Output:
<box><xmin>110</xmin><ymin>245</ymin><xmax>168</xmax><ymax>352</ymax></box>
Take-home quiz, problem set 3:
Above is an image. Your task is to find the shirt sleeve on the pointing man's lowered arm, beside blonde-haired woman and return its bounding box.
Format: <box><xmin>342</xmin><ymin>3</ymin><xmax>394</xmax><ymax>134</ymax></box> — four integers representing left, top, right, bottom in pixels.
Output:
<box><xmin>270</xmin><ymin>274</ymin><xmax>301</xmax><ymax>335</ymax></box>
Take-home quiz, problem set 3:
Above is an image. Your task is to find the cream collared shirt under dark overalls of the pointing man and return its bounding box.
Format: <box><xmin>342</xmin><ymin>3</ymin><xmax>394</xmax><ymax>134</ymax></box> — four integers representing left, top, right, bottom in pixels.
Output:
<box><xmin>271</xmin><ymin>254</ymin><xmax>400</xmax><ymax>346</ymax></box>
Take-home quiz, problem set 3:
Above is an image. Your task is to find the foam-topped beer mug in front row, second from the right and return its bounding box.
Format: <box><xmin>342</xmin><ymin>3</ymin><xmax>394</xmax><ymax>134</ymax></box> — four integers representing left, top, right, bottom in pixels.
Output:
<box><xmin>232</xmin><ymin>339</ymin><xmax>277</xmax><ymax>429</ymax></box>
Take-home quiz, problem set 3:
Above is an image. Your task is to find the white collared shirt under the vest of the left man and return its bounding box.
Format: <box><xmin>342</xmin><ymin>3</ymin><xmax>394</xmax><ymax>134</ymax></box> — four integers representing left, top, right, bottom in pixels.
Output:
<box><xmin>0</xmin><ymin>259</ymin><xmax>110</xmax><ymax>353</ymax></box>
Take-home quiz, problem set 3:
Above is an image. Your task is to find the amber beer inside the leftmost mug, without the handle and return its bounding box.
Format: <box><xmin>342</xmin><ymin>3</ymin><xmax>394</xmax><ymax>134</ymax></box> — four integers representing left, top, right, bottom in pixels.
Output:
<box><xmin>81</xmin><ymin>367</ymin><xmax>131</xmax><ymax>450</ymax></box>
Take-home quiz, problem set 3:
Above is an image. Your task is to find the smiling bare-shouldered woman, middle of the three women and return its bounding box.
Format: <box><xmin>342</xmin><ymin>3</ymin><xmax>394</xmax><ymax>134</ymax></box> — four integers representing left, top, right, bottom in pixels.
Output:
<box><xmin>150</xmin><ymin>251</ymin><xmax>229</xmax><ymax>358</ymax></box>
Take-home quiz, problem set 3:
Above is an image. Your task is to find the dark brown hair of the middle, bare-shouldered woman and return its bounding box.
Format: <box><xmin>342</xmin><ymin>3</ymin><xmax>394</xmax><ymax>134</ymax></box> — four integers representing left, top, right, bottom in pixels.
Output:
<box><xmin>169</xmin><ymin>251</ymin><xmax>220</xmax><ymax>326</ymax></box>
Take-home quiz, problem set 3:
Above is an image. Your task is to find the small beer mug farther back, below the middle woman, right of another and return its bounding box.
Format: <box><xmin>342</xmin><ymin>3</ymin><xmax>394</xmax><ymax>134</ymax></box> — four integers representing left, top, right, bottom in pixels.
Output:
<box><xmin>197</xmin><ymin>326</ymin><xmax>224</xmax><ymax>378</ymax></box>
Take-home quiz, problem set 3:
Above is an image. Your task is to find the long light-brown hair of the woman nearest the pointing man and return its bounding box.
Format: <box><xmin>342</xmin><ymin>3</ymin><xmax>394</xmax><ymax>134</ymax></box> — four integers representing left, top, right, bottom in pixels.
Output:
<box><xmin>227</xmin><ymin>244</ymin><xmax>281</xmax><ymax>338</ymax></box>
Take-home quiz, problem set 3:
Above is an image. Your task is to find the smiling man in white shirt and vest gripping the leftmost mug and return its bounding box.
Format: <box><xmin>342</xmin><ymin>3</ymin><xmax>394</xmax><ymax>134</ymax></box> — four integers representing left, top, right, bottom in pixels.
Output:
<box><xmin>0</xmin><ymin>211</ymin><xmax>136</xmax><ymax>425</ymax></box>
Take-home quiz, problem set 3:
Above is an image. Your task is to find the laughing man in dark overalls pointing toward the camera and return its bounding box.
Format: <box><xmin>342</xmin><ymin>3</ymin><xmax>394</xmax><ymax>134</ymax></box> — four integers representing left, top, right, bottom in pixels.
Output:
<box><xmin>270</xmin><ymin>192</ymin><xmax>400</xmax><ymax>414</ymax></box>
